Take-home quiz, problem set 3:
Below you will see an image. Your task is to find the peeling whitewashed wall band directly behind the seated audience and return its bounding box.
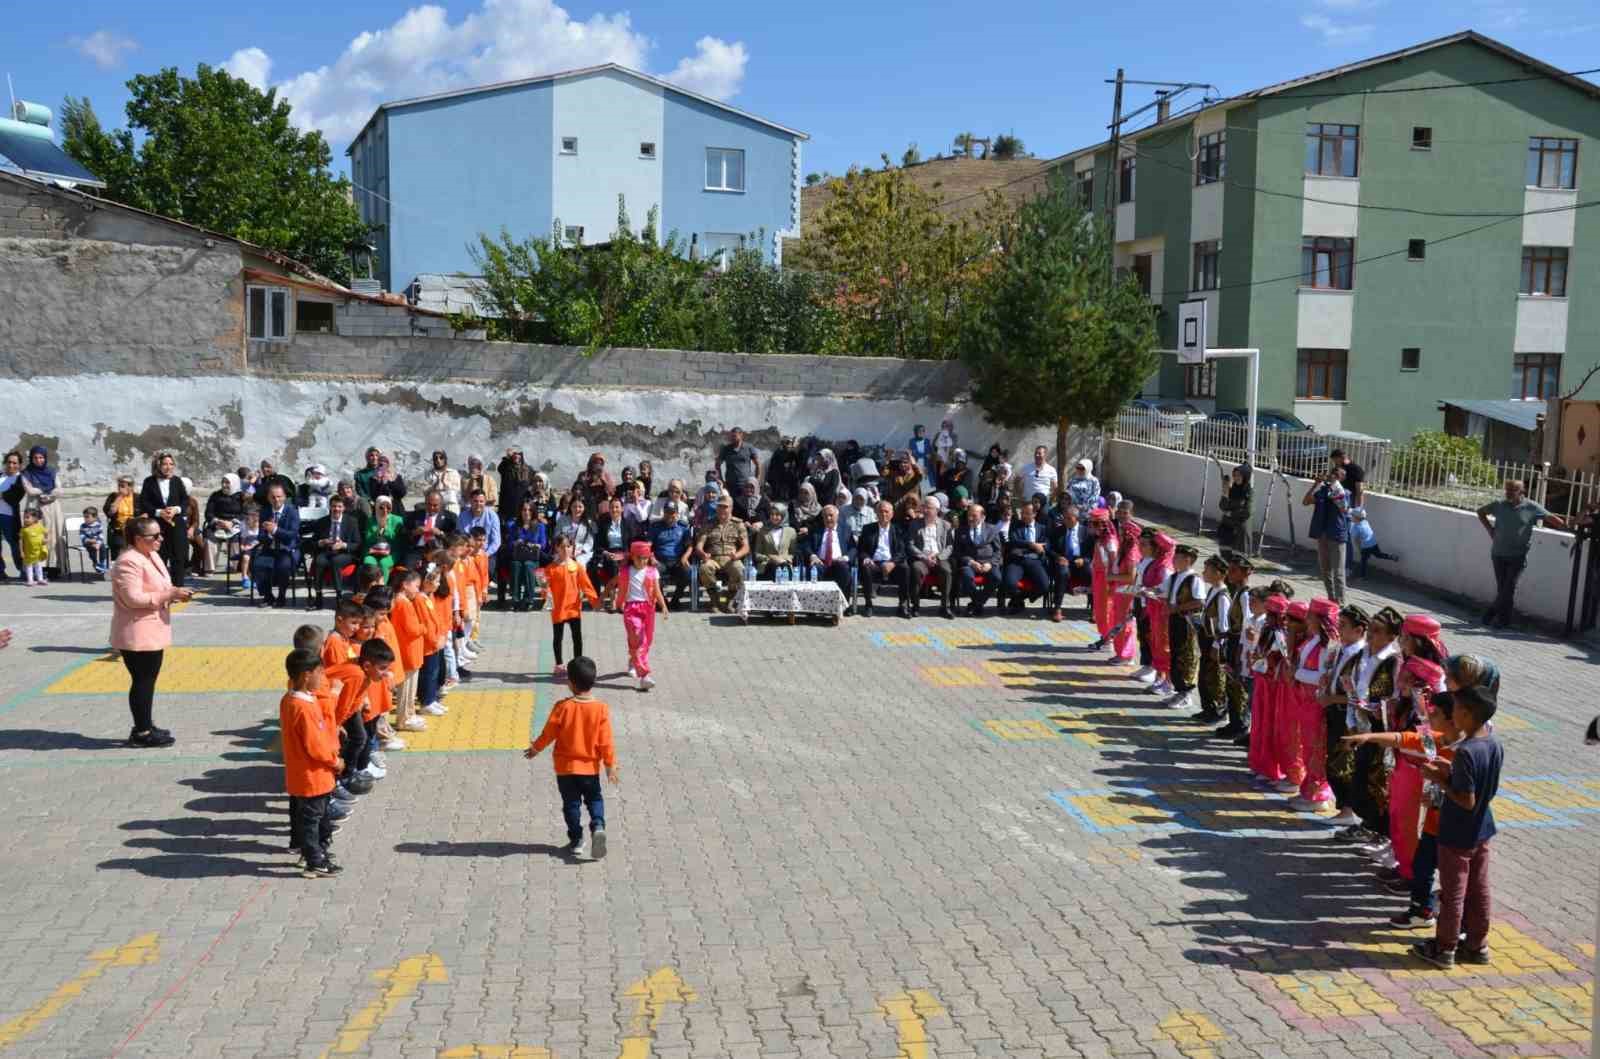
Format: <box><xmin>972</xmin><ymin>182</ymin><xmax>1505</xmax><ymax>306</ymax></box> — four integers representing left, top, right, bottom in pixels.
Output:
<box><xmin>0</xmin><ymin>371</ymin><xmax>1096</xmax><ymax>494</ymax></box>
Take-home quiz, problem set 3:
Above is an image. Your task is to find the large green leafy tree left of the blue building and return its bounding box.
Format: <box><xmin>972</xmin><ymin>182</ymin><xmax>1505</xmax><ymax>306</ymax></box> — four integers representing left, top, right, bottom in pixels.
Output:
<box><xmin>62</xmin><ymin>62</ymin><xmax>368</xmax><ymax>282</ymax></box>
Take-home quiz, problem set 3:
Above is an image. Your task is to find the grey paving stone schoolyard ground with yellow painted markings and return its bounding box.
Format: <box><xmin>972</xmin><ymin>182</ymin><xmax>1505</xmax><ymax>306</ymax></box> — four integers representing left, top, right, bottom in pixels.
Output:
<box><xmin>0</xmin><ymin>518</ymin><xmax>1600</xmax><ymax>1059</ymax></box>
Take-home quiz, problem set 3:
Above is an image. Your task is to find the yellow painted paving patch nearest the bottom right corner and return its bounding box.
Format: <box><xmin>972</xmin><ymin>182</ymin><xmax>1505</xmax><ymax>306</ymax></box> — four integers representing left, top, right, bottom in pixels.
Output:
<box><xmin>1416</xmin><ymin>984</ymin><xmax>1594</xmax><ymax>1046</ymax></box>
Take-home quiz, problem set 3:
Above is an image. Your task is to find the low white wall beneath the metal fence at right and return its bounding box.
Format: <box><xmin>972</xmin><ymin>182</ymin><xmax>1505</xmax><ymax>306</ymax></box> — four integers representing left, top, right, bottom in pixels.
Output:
<box><xmin>1101</xmin><ymin>442</ymin><xmax>1573</xmax><ymax>622</ymax></box>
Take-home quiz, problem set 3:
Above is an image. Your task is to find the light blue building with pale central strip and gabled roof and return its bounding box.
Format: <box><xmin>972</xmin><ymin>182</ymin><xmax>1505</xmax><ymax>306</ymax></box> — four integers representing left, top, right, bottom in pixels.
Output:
<box><xmin>346</xmin><ymin>62</ymin><xmax>806</xmax><ymax>290</ymax></box>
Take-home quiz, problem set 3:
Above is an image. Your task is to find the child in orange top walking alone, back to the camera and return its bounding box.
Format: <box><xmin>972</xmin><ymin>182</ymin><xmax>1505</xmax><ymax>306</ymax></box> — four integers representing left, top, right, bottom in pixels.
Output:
<box><xmin>523</xmin><ymin>654</ymin><xmax>618</xmax><ymax>861</ymax></box>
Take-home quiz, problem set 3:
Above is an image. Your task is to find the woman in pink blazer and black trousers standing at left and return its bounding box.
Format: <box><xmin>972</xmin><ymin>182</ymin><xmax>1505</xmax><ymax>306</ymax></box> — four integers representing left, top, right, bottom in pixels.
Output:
<box><xmin>110</xmin><ymin>517</ymin><xmax>194</xmax><ymax>747</ymax></box>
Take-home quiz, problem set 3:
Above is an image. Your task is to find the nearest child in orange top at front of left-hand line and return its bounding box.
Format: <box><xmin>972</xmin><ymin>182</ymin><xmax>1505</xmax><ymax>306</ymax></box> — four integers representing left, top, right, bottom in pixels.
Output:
<box><xmin>278</xmin><ymin>648</ymin><xmax>344</xmax><ymax>878</ymax></box>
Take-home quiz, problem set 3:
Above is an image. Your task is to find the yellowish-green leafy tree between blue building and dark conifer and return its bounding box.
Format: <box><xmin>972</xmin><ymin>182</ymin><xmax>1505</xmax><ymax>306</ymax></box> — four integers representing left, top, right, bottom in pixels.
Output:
<box><xmin>789</xmin><ymin>168</ymin><xmax>1005</xmax><ymax>360</ymax></box>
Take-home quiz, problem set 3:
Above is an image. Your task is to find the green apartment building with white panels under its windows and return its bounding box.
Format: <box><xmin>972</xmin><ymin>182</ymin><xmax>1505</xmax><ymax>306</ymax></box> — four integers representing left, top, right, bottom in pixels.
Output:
<box><xmin>1059</xmin><ymin>32</ymin><xmax>1600</xmax><ymax>442</ymax></box>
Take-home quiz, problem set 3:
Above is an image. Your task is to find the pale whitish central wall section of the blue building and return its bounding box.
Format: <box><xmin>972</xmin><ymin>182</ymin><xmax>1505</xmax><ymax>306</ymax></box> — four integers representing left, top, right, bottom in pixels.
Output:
<box><xmin>550</xmin><ymin>72</ymin><xmax>672</xmax><ymax>243</ymax></box>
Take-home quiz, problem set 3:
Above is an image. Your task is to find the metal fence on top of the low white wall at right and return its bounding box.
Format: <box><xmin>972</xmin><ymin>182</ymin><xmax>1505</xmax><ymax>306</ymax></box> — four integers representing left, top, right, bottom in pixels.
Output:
<box><xmin>1110</xmin><ymin>408</ymin><xmax>1600</xmax><ymax>518</ymax></box>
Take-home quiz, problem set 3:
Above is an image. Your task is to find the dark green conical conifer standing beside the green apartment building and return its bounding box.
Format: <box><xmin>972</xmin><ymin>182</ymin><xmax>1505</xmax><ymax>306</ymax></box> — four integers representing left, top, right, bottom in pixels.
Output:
<box><xmin>962</xmin><ymin>173</ymin><xmax>1160</xmax><ymax>476</ymax></box>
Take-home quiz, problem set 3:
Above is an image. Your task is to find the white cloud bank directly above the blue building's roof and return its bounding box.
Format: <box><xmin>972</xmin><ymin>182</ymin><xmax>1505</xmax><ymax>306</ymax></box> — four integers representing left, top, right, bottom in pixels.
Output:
<box><xmin>222</xmin><ymin>0</ymin><xmax>749</xmax><ymax>146</ymax></box>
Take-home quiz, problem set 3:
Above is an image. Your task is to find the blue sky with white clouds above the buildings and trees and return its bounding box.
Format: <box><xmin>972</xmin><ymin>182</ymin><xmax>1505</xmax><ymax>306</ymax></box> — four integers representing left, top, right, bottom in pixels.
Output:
<box><xmin>9</xmin><ymin>0</ymin><xmax>1600</xmax><ymax>171</ymax></box>
